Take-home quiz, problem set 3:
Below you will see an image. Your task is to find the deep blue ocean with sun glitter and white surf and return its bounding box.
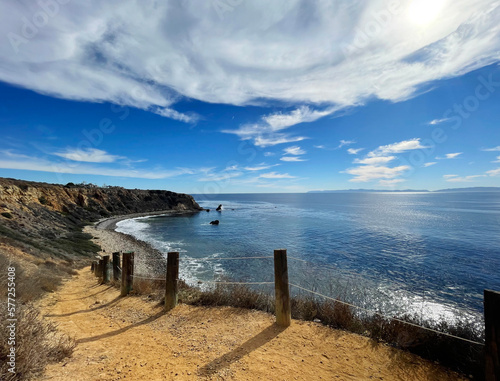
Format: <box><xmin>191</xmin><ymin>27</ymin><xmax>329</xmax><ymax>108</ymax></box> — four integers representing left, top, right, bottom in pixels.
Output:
<box><xmin>117</xmin><ymin>192</ymin><xmax>500</xmax><ymax>321</ymax></box>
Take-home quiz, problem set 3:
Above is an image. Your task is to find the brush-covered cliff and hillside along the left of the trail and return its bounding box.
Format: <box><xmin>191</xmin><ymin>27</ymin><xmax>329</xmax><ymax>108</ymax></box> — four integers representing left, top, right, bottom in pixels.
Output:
<box><xmin>0</xmin><ymin>178</ymin><xmax>203</xmax><ymax>380</ymax></box>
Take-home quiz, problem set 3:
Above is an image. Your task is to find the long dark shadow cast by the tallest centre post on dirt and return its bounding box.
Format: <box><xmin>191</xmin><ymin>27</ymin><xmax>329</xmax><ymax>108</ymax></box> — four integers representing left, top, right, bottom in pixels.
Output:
<box><xmin>198</xmin><ymin>323</ymin><xmax>286</xmax><ymax>376</ymax></box>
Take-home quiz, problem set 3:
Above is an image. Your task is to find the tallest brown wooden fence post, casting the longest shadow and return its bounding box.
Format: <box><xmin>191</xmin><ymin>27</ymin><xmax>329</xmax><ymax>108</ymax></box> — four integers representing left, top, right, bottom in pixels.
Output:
<box><xmin>274</xmin><ymin>249</ymin><xmax>292</xmax><ymax>327</ymax></box>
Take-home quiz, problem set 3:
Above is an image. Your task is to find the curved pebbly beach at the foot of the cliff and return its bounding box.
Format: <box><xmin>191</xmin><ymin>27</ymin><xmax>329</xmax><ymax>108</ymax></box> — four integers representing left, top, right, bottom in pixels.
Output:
<box><xmin>87</xmin><ymin>210</ymin><xmax>200</xmax><ymax>276</ymax></box>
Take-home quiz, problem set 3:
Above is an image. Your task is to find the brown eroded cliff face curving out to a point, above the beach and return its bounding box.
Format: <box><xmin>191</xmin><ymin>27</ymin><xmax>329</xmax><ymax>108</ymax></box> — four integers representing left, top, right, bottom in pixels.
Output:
<box><xmin>0</xmin><ymin>178</ymin><xmax>201</xmax><ymax>258</ymax></box>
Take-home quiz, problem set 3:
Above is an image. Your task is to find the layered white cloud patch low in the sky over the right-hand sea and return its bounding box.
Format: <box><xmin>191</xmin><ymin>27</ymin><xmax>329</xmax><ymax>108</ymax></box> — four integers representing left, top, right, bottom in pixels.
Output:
<box><xmin>341</xmin><ymin>138</ymin><xmax>426</xmax><ymax>186</ymax></box>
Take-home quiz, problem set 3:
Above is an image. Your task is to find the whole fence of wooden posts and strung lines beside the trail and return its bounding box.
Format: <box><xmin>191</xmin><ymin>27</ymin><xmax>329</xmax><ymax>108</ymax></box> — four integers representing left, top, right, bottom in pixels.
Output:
<box><xmin>91</xmin><ymin>249</ymin><xmax>500</xmax><ymax>374</ymax></box>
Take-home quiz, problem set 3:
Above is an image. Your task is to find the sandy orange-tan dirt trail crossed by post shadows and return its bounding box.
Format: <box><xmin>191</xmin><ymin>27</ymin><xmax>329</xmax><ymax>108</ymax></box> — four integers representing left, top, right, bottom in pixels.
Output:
<box><xmin>41</xmin><ymin>268</ymin><xmax>459</xmax><ymax>381</ymax></box>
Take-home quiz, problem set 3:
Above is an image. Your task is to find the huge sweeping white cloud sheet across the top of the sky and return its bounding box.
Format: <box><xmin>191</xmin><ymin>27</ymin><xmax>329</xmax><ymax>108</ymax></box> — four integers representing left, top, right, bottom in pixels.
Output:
<box><xmin>0</xmin><ymin>0</ymin><xmax>500</xmax><ymax>123</ymax></box>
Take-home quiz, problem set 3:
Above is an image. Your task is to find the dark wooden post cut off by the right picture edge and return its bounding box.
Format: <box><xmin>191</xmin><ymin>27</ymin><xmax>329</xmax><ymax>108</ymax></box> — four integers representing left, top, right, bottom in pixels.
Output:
<box><xmin>484</xmin><ymin>290</ymin><xmax>500</xmax><ymax>381</ymax></box>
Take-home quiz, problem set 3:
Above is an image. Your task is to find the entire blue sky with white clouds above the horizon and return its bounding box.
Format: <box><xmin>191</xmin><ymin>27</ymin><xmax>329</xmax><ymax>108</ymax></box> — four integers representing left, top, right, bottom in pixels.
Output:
<box><xmin>0</xmin><ymin>0</ymin><xmax>500</xmax><ymax>194</ymax></box>
